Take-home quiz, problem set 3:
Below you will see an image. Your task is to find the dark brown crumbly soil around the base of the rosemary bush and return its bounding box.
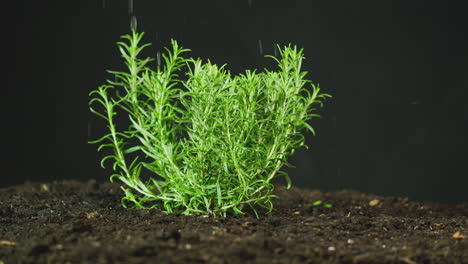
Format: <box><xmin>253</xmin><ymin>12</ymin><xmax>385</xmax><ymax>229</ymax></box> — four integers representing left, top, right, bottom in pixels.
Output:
<box><xmin>0</xmin><ymin>181</ymin><xmax>468</xmax><ymax>264</ymax></box>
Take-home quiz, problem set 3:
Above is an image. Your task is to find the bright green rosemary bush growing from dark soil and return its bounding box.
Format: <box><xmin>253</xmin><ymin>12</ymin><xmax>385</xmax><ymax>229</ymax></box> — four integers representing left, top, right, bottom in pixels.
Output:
<box><xmin>90</xmin><ymin>32</ymin><xmax>329</xmax><ymax>216</ymax></box>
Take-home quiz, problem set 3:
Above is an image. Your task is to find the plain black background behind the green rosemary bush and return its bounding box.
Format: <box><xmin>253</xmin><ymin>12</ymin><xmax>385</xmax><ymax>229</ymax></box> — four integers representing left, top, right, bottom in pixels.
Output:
<box><xmin>4</xmin><ymin>0</ymin><xmax>468</xmax><ymax>202</ymax></box>
